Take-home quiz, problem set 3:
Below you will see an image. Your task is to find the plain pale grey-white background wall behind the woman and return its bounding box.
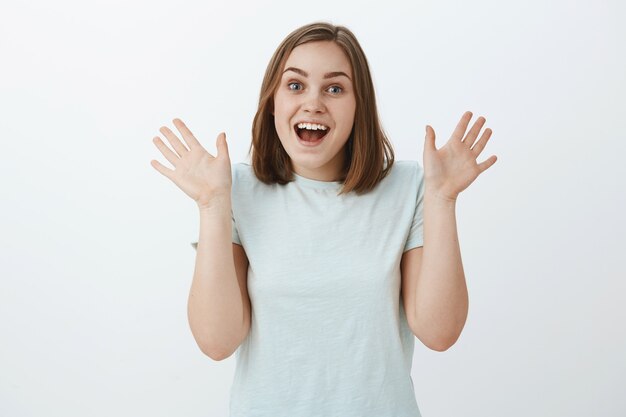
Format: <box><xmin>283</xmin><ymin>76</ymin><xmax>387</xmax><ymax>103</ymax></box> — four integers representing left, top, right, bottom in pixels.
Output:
<box><xmin>0</xmin><ymin>0</ymin><xmax>626</xmax><ymax>417</ymax></box>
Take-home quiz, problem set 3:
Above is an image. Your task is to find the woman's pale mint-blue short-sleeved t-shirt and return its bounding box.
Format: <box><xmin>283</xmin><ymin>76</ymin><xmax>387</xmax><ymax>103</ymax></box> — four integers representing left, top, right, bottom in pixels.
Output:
<box><xmin>193</xmin><ymin>161</ymin><xmax>424</xmax><ymax>417</ymax></box>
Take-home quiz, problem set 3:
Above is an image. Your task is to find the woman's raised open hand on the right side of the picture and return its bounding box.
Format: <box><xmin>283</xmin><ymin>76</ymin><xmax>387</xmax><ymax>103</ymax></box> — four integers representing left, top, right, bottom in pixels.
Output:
<box><xmin>424</xmin><ymin>111</ymin><xmax>498</xmax><ymax>201</ymax></box>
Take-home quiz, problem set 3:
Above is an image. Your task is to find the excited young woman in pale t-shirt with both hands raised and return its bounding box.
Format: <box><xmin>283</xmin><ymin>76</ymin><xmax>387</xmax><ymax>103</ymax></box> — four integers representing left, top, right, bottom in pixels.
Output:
<box><xmin>151</xmin><ymin>23</ymin><xmax>496</xmax><ymax>417</ymax></box>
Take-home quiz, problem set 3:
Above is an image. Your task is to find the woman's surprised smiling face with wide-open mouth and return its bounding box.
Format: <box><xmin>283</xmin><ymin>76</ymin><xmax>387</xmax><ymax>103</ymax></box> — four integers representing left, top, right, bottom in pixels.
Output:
<box><xmin>273</xmin><ymin>41</ymin><xmax>356</xmax><ymax>181</ymax></box>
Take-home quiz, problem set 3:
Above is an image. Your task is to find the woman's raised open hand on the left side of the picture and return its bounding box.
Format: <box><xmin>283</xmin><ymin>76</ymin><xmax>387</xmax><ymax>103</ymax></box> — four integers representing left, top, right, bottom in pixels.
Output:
<box><xmin>150</xmin><ymin>119</ymin><xmax>232</xmax><ymax>209</ymax></box>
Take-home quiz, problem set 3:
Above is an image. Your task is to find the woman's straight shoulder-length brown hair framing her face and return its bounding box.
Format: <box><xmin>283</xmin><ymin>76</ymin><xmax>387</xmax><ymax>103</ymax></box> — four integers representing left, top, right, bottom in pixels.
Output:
<box><xmin>248</xmin><ymin>22</ymin><xmax>394</xmax><ymax>194</ymax></box>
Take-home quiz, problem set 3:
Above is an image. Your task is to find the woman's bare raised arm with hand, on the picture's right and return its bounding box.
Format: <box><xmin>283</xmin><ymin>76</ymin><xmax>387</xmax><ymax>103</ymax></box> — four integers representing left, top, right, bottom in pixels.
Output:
<box><xmin>401</xmin><ymin>111</ymin><xmax>497</xmax><ymax>351</ymax></box>
